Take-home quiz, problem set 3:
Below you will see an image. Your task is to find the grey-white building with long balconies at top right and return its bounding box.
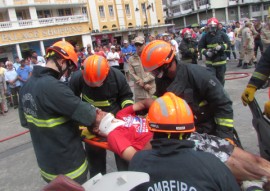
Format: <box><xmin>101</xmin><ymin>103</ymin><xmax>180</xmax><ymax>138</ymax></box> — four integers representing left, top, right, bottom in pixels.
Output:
<box><xmin>163</xmin><ymin>0</ymin><xmax>270</xmax><ymax>32</ymax></box>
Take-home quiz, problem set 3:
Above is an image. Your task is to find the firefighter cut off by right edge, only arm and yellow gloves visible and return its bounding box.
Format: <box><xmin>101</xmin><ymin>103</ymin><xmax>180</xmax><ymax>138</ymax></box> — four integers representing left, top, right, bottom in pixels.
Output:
<box><xmin>242</xmin><ymin>47</ymin><xmax>270</xmax><ymax>119</ymax></box>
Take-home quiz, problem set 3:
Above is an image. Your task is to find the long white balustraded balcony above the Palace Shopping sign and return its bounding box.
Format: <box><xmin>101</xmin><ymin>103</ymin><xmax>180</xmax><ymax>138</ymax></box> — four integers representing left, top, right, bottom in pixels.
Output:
<box><xmin>0</xmin><ymin>15</ymin><xmax>88</xmax><ymax>31</ymax></box>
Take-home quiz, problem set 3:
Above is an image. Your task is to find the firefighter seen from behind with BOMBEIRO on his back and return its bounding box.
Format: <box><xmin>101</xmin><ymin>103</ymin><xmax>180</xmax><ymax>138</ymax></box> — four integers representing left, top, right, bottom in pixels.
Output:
<box><xmin>129</xmin><ymin>93</ymin><xmax>240</xmax><ymax>191</ymax></box>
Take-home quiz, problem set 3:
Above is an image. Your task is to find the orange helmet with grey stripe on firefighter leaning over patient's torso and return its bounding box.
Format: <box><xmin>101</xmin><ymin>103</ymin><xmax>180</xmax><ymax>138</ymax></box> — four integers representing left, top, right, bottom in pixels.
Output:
<box><xmin>141</xmin><ymin>40</ymin><xmax>175</xmax><ymax>72</ymax></box>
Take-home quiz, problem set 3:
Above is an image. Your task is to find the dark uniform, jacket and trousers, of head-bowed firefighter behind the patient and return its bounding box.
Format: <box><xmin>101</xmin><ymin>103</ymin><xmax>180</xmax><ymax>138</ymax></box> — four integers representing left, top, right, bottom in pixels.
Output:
<box><xmin>70</xmin><ymin>67</ymin><xmax>133</xmax><ymax>177</ymax></box>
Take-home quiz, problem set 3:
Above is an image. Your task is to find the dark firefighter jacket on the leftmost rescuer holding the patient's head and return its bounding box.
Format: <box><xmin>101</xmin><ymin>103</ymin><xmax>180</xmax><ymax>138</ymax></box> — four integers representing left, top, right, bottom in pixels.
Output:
<box><xmin>19</xmin><ymin>66</ymin><xmax>96</xmax><ymax>181</ymax></box>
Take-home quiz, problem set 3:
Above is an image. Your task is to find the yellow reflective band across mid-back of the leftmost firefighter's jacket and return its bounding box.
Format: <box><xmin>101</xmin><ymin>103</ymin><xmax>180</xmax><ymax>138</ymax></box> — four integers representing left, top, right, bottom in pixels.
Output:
<box><xmin>24</xmin><ymin>113</ymin><xmax>69</xmax><ymax>128</ymax></box>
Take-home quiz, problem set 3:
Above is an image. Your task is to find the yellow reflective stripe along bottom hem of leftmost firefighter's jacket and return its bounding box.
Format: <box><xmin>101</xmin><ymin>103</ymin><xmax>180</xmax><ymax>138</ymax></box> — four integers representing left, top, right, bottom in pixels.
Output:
<box><xmin>40</xmin><ymin>160</ymin><xmax>87</xmax><ymax>180</ymax></box>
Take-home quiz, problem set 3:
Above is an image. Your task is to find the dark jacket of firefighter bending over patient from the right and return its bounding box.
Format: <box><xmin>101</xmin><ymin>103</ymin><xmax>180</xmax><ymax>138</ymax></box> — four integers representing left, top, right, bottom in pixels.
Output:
<box><xmin>156</xmin><ymin>64</ymin><xmax>234</xmax><ymax>140</ymax></box>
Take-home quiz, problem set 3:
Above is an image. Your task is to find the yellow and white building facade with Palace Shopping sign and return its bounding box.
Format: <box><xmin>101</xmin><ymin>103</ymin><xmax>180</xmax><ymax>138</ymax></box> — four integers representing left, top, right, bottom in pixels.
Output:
<box><xmin>0</xmin><ymin>0</ymin><xmax>172</xmax><ymax>61</ymax></box>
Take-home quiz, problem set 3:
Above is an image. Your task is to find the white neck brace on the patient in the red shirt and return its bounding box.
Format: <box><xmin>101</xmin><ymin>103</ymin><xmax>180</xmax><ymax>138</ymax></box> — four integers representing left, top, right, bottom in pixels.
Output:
<box><xmin>99</xmin><ymin>113</ymin><xmax>125</xmax><ymax>137</ymax></box>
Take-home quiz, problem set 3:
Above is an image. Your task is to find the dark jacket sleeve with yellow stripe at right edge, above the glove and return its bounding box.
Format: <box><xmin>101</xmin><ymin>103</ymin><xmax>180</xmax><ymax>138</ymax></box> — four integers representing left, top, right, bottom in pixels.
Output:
<box><xmin>249</xmin><ymin>47</ymin><xmax>270</xmax><ymax>89</ymax></box>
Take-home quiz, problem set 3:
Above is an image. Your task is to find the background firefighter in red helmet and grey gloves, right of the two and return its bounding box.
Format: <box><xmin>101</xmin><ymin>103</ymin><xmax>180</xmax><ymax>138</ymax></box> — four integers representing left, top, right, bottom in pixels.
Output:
<box><xmin>199</xmin><ymin>18</ymin><xmax>230</xmax><ymax>86</ymax></box>
